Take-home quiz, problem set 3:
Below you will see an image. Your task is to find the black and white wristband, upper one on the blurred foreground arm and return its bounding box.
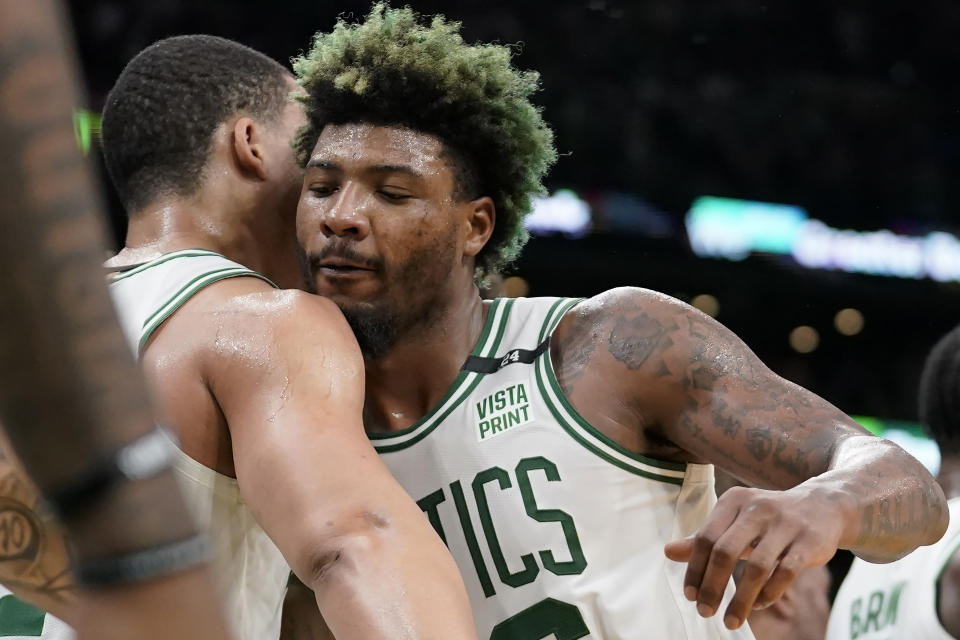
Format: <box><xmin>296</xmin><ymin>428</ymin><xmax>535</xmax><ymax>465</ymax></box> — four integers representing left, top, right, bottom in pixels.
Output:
<box><xmin>46</xmin><ymin>427</ymin><xmax>176</xmax><ymax>521</ymax></box>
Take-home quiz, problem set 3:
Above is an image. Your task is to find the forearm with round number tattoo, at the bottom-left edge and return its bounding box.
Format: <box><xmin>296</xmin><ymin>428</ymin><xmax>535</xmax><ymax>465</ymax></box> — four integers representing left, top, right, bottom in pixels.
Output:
<box><xmin>0</xmin><ymin>432</ymin><xmax>77</xmax><ymax>622</ymax></box>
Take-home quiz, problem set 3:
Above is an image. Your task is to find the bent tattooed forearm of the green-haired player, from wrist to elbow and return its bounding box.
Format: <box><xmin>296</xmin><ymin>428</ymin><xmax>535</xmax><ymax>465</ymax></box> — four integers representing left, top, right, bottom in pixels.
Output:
<box><xmin>797</xmin><ymin>436</ymin><xmax>949</xmax><ymax>562</ymax></box>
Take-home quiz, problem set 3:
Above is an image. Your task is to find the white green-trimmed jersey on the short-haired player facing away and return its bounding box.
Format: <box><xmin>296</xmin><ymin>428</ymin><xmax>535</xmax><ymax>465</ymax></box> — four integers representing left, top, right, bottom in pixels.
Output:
<box><xmin>108</xmin><ymin>249</ymin><xmax>290</xmax><ymax>640</ymax></box>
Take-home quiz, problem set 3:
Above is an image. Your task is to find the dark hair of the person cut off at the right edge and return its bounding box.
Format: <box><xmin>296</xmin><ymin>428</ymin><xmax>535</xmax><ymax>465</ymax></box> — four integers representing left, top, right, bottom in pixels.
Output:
<box><xmin>920</xmin><ymin>327</ymin><xmax>960</xmax><ymax>456</ymax></box>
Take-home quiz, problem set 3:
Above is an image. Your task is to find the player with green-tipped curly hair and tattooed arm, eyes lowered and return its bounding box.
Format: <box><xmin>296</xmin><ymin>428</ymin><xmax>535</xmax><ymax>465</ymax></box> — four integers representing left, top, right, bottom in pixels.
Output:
<box><xmin>295</xmin><ymin>4</ymin><xmax>947</xmax><ymax>640</ymax></box>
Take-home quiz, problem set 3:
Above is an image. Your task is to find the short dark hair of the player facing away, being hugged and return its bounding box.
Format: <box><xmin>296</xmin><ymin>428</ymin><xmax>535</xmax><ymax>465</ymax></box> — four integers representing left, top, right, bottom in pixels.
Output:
<box><xmin>102</xmin><ymin>35</ymin><xmax>291</xmax><ymax>213</ymax></box>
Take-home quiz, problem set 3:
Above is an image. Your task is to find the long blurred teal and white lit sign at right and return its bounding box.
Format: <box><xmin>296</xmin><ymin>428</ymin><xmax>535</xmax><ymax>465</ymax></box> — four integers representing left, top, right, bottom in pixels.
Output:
<box><xmin>686</xmin><ymin>196</ymin><xmax>960</xmax><ymax>282</ymax></box>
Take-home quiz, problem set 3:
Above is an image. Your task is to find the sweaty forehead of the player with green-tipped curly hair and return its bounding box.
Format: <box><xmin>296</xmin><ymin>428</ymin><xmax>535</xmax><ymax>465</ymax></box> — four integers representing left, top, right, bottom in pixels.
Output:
<box><xmin>309</xmin><ymin>123</ymin><xmax>449</xmax><ymax>176</ymax></box>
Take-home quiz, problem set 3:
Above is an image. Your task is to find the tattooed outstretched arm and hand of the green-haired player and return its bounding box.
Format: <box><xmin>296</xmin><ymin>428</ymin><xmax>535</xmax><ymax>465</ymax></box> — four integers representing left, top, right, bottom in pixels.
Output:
<box><xmin>556</xmin><ymin>289</ymin><xmax>948</xmax><ymax>627</ymax></box>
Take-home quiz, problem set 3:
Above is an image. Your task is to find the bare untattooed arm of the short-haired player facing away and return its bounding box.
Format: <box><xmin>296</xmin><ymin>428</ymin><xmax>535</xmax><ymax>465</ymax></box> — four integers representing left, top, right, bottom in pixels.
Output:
<box><xmin>208</xmin><ymin>292</ymin><xmax>476</xmax><ymax>640</ymax></box>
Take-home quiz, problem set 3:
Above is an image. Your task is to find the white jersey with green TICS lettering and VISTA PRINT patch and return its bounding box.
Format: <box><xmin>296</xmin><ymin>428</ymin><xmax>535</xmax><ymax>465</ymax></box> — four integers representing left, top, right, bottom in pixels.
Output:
<box><xmin>371</xmin><ymin>298</ymin><xmax>753</xmax><ymax>640</ymax></box>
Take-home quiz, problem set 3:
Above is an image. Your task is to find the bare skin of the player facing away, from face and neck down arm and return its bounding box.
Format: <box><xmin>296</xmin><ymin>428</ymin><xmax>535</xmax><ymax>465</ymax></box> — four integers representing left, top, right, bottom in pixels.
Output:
<box><xmin>109</xmin><ymin>74</ymin><xmax>476</xmax><ymax>640</ymax></box>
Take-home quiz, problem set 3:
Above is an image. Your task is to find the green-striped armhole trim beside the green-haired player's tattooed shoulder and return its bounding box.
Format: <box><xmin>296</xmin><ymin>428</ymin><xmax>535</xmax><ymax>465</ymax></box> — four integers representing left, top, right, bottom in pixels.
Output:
<box><xmin>536</xmin><ymin>299</ymin><xmax>687</xmax><ymax>485</ymax></box>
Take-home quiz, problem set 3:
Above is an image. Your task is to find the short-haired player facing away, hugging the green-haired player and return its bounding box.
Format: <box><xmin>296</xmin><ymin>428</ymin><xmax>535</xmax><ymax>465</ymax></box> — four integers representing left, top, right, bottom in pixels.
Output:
<box><xmin>103</xmin><ymin>36</ymin><xmax>475</xmax><ymax>640</ymax></box>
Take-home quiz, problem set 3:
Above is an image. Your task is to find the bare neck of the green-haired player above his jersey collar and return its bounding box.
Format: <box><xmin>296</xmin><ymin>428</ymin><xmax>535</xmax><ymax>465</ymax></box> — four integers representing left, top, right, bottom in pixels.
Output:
<box><xmin>364</xmin><ymin>284</ymin><xmax>489</xmax><ymax>432</ymax></box>
